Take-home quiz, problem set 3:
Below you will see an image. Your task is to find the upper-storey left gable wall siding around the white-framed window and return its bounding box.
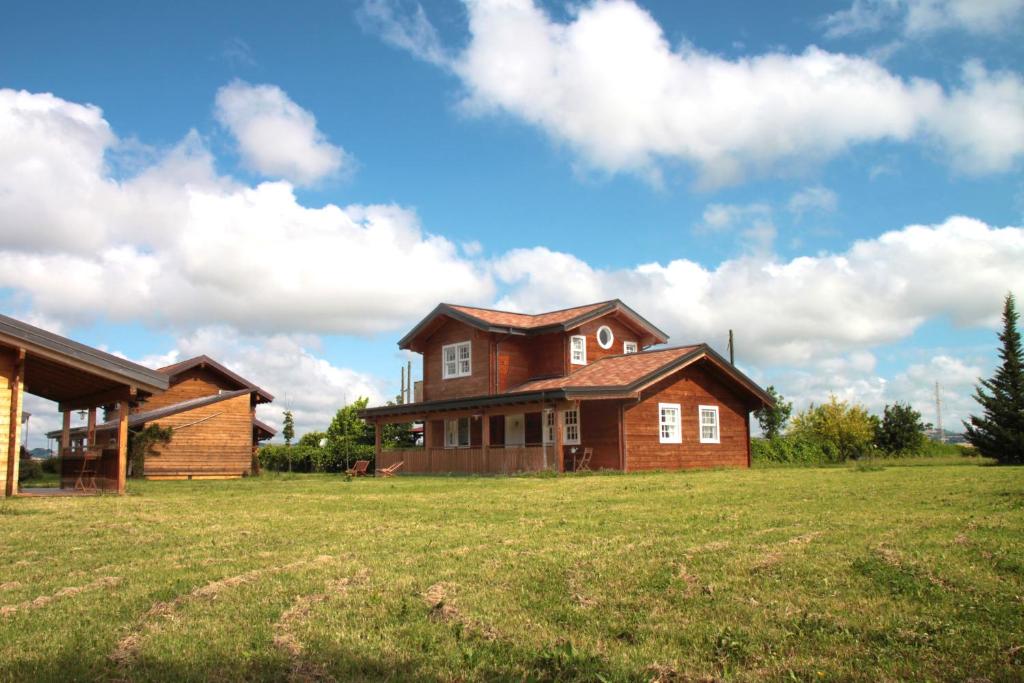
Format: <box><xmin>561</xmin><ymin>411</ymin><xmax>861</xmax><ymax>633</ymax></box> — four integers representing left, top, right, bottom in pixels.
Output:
<box><xmin>423</xmin><ymin>321</ymin><xmax>493</xmax><ymax>400</ymax></box>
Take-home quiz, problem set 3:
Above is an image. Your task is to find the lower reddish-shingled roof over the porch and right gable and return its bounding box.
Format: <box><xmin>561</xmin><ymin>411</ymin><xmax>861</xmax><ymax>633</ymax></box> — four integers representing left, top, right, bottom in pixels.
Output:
<box><xmin>359</xmin><ymin>344</ymin><xmax>773</xmax><ymax>418</ymax></box>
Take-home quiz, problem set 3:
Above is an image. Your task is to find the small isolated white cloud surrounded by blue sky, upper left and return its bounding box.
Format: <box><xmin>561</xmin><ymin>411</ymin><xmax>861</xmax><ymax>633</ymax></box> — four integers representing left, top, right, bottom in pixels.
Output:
<box><xmin>214</xmin><ymin>81</ymin><xmax>352</xmax><ymax>185</ymax></box>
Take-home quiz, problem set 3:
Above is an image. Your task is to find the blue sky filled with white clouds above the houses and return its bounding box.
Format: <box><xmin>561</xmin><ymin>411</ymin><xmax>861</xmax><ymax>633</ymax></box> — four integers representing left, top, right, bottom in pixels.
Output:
<box><xmin>0</xmin><ymin>0</ymin><xmax>1024</xmax><ymax>445</ymax></box>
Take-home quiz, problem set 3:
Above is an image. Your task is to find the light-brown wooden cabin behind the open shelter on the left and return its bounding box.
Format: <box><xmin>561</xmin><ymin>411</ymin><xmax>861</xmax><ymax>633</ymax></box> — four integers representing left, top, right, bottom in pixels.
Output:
<box><xmin>50</xmin><ymin>355</ymin><xmax>275</xmax><ymax>479</ymax></box>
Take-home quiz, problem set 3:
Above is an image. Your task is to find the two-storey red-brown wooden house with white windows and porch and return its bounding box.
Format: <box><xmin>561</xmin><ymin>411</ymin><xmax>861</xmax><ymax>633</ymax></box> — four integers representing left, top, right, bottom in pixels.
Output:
<box><xmin>361</xmin><ymin>299</ymin><xmax>771</xmax><ymax>473</ymax></box>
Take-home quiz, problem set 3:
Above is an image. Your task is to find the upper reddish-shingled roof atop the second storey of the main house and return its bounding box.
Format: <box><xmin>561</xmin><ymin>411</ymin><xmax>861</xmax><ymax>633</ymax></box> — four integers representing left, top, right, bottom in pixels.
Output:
<box><xmin>398</xmin><ymin>299</ymin><xmax>669</xmax><ymax>350</ymax></box>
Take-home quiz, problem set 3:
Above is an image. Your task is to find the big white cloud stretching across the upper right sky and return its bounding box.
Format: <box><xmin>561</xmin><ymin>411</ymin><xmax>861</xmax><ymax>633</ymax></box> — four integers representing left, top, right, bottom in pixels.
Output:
<box><xmin>366</xmin><ymin>0</ymin><xmax>1024</xmax><ymax>186</ymax></box>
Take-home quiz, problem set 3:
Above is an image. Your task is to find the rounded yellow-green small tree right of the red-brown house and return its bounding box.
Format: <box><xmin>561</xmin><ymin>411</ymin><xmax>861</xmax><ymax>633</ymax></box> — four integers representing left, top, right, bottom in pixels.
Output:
<box><xmin>790</xmin><ymin>395</ymin><xmax>878</xmax><ymax>462</ymax></box>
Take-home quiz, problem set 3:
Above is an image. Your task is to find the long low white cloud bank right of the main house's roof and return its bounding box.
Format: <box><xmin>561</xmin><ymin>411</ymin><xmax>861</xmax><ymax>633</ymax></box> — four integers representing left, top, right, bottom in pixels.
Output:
<box><xmin>494</xmin><ymin>217</ymin><xmax>1024</xmax><ymax>366</ymax></box>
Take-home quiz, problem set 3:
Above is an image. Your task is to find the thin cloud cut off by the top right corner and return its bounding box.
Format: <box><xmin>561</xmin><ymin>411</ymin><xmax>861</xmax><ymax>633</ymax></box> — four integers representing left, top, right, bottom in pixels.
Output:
<box><xmin>822</xmin><ymin>0</ymin><xmax>1024</xmax><ymax>38</ymax></box>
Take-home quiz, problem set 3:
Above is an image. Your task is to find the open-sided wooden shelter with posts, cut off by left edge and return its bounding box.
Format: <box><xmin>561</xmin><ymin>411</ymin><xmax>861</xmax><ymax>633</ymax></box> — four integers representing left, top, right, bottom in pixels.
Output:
<box><xmin>0</xmin><ymin>315</ymin><xmax>168</xmax><ymax>496</ymax></box>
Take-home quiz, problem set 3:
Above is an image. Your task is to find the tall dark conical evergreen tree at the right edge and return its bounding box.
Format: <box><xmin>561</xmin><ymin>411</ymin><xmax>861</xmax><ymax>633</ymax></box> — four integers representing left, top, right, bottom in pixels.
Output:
<box><xmin>964</xmin><ymin>293</ymin><xmax>1024</xmax><ymax>465</ymax></box>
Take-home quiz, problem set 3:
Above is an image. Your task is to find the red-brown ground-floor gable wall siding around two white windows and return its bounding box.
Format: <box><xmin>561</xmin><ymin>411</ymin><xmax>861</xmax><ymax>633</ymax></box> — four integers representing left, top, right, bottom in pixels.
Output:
<box><xmin>618</xmin><ymin>361</ymin><xmax>750</xmax><ymax>471</ymax></box>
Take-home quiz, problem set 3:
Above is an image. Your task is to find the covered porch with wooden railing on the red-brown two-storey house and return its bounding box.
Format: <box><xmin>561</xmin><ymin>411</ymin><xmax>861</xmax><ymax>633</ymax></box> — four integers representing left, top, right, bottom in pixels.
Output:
<box><xmin>368</xmin><ymin>396</ymin><xmax>623</xmax><ymax>474</ymax></box>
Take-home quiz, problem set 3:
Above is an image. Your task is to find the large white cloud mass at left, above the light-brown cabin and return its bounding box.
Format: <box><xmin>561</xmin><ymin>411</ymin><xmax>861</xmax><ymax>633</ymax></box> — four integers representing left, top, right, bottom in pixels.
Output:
<box><xmin>0</xmin><ymin>90</ymin><xmax>494</xmax><ymax>334</ymax></box>
